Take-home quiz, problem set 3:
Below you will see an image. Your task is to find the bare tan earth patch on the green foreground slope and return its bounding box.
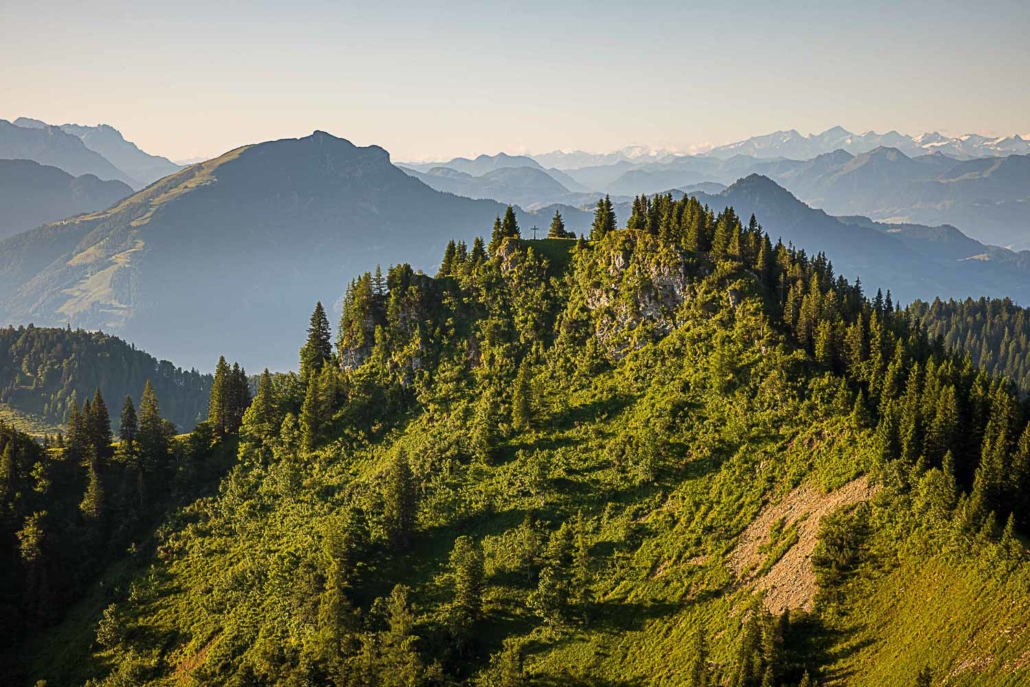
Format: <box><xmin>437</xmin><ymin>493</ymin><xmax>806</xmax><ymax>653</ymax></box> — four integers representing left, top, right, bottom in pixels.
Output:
<box><xmin>729</xmin><ymin>476</ymin><xmax>873</xmax><ymax>613</ymax></box>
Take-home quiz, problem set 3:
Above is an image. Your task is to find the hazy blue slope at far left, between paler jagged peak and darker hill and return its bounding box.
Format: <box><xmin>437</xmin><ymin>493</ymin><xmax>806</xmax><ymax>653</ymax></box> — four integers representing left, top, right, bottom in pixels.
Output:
<box><xmin>0</xmin><ymin>119</ymin><xmax>133</xmax><ymax>185</ymax></box>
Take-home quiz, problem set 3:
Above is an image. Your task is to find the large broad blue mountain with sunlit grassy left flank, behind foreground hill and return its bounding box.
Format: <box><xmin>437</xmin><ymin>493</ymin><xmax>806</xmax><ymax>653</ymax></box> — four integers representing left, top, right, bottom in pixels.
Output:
<box><xmin>0</xmin><ymin>130</ymin><xmax>523</xmax><ymax>370</ymax></box>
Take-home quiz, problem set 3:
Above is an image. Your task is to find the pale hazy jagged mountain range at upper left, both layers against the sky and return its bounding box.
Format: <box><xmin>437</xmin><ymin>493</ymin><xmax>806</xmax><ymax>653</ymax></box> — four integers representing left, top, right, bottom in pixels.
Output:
<box><xmin>0</xmin><ymin>117</ymin><xmax>182</xmax><ymax>190</ymax></box>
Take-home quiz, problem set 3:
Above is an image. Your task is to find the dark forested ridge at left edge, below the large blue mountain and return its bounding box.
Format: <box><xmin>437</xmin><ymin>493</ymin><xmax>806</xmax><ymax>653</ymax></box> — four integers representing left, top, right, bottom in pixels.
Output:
<box><xmin>0</xmin><ymin>324</ymin><xmax>211</xmax><ymax>431</ymax></box>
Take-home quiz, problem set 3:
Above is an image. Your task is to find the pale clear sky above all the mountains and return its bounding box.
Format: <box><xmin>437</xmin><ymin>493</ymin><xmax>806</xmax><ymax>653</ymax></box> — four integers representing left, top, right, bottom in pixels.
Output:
<box><xmin>0</xmin><ymin>0</ymin><xmax>1030</xmax><ymax>160</ymax></box>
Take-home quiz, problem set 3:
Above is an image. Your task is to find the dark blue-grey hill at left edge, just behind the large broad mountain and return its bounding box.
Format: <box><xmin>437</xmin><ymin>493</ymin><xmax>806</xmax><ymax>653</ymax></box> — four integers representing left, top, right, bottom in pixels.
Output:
<box><xmin>0</xmin><ymin>160</ymin><xmax>132</xmax><ymax>239</ymax></box>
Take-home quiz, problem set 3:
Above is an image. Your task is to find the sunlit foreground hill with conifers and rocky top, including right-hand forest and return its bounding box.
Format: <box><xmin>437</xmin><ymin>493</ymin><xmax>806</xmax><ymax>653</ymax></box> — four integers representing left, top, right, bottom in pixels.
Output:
<box><xmin>5</xmin><ymin>196</ymin><xmax>1030</xmax><ymax>687</ymax></box>
